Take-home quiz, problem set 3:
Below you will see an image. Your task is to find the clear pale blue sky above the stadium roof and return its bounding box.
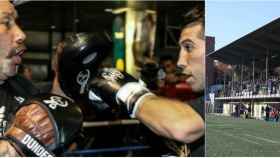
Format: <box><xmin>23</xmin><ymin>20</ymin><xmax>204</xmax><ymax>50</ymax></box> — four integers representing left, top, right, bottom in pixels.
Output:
<box><xmin>205</xmin><ymin>0</ymin><xmax>280</xmax><ymax>50</ymax></box>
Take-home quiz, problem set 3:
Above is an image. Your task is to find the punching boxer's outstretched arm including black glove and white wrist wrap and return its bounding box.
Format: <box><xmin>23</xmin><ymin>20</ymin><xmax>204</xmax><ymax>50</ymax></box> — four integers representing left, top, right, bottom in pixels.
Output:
<box><xmin>89</xmin><ymin>68</ymin><xmax>204</xmax><ymax>143</ymax></box>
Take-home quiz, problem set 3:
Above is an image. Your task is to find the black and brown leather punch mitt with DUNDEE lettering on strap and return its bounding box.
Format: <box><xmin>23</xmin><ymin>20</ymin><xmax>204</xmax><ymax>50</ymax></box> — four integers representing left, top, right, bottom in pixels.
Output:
<box><xmin>5</xmin><ymin>94</ymin><xmax>82</xmax><ymax>157</ymax></box>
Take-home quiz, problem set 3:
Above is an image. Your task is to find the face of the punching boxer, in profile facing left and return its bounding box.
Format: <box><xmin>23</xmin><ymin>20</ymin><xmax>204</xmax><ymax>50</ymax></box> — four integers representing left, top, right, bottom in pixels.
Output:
<box><xmin>177</xmin><ymin>24</ymin><xmax>205</xmax><ymax>92</ymax></box>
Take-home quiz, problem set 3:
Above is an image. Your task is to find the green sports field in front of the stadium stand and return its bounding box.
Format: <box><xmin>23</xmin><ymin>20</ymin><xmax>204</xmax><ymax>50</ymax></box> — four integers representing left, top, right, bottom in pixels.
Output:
<box><xmin>206</xmin><ymin>114</ymin><xmax>280</xmax><ymax>157</ymax></box>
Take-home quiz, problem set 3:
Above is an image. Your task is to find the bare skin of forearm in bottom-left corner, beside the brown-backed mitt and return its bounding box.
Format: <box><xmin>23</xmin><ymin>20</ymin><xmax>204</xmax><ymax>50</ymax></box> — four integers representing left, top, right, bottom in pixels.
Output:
<box><xmin>0</xmin><ymin>140</ymin><xmax>20</xmax><ymax>157</ymax></box>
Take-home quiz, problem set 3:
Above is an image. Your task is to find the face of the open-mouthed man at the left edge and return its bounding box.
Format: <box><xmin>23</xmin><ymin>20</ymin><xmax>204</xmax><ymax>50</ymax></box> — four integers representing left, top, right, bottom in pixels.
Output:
<box><xmin>0</xmin><ymin>1</ymin><xmax>25</xmax><ymax>81</ymax></box>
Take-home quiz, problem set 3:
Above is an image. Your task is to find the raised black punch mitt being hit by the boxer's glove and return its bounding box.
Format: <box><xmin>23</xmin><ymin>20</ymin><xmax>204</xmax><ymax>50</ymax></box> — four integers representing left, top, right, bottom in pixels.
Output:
<box><xmin>58</xmin><ymin>33</ymin><xmax>112</xmax><ymax>100</ymax></box>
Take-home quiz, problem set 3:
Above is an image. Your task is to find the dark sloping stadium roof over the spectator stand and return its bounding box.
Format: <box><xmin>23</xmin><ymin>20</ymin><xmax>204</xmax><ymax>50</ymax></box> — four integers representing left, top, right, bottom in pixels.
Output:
<box><xmin>207</xmin><ymin>18</ymin><xmax>280</xmax><ymax>68</ymax></box>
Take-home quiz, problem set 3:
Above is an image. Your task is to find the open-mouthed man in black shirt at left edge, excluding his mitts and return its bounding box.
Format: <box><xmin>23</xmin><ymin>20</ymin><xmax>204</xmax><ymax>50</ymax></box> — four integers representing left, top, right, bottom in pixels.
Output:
<box><xmin>0</xmin><ymin>0</ymin><xmax>37</xmax><ymax>134</ymax></box>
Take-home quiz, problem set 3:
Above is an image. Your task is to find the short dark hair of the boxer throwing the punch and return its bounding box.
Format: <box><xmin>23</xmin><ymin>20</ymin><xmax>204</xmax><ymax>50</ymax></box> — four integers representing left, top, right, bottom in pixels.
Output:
<box><xmin>182</xmin><ymin>5</ymin><xmax>205</xmax><ymax>39</ymax></box>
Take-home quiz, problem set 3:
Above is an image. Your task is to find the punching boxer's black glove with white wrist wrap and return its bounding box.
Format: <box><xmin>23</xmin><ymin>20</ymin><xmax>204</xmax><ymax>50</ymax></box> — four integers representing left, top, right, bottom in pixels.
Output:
<box><xmin>88</xmin><ymin>68</ymin><xmax>154</xmax><ymax>118</ymax></box>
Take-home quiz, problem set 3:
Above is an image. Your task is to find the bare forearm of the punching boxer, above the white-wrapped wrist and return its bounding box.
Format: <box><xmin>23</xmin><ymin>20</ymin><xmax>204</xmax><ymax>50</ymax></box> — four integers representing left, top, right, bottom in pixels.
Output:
<box><xmin>136</xmin><ymin>96</ymin><xmax>204</xmax><ymax>143</ymax></box>
